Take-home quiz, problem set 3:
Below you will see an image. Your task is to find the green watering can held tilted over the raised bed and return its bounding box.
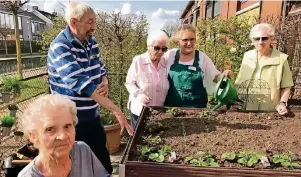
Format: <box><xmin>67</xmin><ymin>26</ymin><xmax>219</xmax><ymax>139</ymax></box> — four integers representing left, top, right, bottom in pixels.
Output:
<box><xmin>212</xmin><ymin>74</ymin><xmax>243</xmax><ymax>111</ymax></box>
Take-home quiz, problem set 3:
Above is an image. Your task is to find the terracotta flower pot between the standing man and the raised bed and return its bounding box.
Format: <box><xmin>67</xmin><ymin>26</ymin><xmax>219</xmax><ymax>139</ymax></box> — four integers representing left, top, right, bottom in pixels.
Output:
<box><xmin>104</xmin><ymin>123</ymin><xmax>121</xmax><ymax>154</ymax></box>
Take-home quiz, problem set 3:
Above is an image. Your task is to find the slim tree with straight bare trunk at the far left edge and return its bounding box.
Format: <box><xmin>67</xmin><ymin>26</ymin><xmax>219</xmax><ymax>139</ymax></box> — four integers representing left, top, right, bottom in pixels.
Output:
<box><xmin>0</xmin><ymin>0</ymin><xmax>29</xmax><ymax>78</ymax></box>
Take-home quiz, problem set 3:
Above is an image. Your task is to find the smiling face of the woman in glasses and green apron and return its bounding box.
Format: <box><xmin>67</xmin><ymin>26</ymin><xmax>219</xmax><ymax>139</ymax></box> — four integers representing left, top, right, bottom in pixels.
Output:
<box><xmin>178</xmin><ymin>30</ymin><xmax>196</xmax><ymax>55</ymax></box>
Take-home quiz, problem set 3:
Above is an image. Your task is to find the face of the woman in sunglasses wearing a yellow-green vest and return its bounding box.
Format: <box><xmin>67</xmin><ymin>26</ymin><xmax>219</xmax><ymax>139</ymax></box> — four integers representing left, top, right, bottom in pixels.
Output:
<box><xmin>252</xmin><ymin>30</ymin><xmax>272</xmax><ymax>51</ymax></box>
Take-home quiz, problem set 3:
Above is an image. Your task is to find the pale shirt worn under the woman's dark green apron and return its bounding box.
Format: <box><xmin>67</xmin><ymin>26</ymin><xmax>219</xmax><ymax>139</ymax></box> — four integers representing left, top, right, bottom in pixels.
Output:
<box><xmin>164</xmin><ymin>48</ymin><xmax>221</xmax><ymax>95</ymax></box>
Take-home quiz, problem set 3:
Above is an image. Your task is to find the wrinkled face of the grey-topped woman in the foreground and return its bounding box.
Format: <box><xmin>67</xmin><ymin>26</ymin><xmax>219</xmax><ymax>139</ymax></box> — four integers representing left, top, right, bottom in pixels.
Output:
<box><xmin>31</xmin><ymin>108</ymin><xmax>75</xmax><ymax>158</ymax></box>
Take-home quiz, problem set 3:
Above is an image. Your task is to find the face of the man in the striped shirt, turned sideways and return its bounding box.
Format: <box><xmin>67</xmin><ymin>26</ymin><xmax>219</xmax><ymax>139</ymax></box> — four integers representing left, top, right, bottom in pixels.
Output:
<box><xmin>71</xmin><ymin>12</ymin><xmax>96</xmax><ymax>41</ymax></box>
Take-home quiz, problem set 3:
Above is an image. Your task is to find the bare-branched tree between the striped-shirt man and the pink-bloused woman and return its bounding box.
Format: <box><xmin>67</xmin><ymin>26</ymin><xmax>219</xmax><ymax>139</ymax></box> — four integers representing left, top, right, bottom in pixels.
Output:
<box><xmin>95</xmin><ymin>12</ymin><xmax>148</xmax><ymax>108</ymax></box>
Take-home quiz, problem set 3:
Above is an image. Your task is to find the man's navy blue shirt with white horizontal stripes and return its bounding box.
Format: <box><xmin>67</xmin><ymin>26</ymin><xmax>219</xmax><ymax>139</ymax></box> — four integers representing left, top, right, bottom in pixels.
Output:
<box><xmin>47</xmin><ymin>26</ymin><xmax>108</xmax><ymax>120</ymax></box>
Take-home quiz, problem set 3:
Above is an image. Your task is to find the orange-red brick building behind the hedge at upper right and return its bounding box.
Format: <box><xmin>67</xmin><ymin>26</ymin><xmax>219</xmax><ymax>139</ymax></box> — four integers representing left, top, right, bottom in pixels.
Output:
<box><xmin>180</xmin><ymin>0</ymin><xmax>301</xmax><ymax>25</ymax></box>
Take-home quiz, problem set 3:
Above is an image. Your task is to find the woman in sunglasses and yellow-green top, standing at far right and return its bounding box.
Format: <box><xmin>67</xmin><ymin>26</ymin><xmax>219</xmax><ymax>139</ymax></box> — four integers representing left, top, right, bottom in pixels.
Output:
<box><xmin>235</xmin><ymin>23</ymin><xmax>294</xmax><ymax>115</ymax></box>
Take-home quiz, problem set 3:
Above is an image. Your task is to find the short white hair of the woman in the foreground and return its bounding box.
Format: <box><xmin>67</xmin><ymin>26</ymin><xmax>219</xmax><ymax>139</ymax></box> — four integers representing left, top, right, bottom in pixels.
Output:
<box><xmin>20</xmin><ymin>94</ymin><xmax>78</xmax><ymax>138</ymax></box>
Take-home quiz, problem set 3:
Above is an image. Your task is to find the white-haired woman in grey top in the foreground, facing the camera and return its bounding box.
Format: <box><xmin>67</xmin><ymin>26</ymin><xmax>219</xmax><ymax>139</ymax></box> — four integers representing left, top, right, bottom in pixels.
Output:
<box><xmin>18</xmin><ymin>95</ymin><xmax>107</xmax><ymax>177</ymax></box>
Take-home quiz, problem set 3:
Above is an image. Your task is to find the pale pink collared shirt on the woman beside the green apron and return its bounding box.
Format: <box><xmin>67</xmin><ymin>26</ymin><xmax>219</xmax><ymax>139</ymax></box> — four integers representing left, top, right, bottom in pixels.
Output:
<box><xmin>125</xmin><ymin>52</ymin><xmax>169</xmax><ymax>114</ymax></box>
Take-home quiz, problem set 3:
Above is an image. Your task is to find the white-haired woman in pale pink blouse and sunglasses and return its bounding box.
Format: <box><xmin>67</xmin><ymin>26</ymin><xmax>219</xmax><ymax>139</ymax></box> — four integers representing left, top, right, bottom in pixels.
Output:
<box><xmin>125</xmin><ymin>30</ymin><xmax>169</xmax><ymax>128</ymax></box>
